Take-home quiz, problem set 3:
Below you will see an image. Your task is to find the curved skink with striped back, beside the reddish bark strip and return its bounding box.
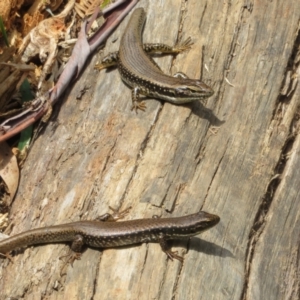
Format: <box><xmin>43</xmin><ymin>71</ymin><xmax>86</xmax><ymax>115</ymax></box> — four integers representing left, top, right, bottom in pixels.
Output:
<box><xmin>95</xmin><ymin>8</ymin><xmax>213</xmax><ymax>110</ymax></box>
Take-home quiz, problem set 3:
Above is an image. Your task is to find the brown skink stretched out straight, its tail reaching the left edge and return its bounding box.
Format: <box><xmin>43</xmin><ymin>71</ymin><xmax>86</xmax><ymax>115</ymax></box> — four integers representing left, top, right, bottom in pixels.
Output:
<box><xmin>0</xmin><ymin>211</ymin><xmax>220</xmax><ymax>262</ymax></box>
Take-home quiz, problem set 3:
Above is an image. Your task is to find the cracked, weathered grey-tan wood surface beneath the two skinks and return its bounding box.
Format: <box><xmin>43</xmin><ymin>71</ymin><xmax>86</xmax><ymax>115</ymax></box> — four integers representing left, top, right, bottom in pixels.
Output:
<box><xmin>0</xmin><ymin>0</ymin><xmax>300</xmax><ymax>299</ymax></box>
